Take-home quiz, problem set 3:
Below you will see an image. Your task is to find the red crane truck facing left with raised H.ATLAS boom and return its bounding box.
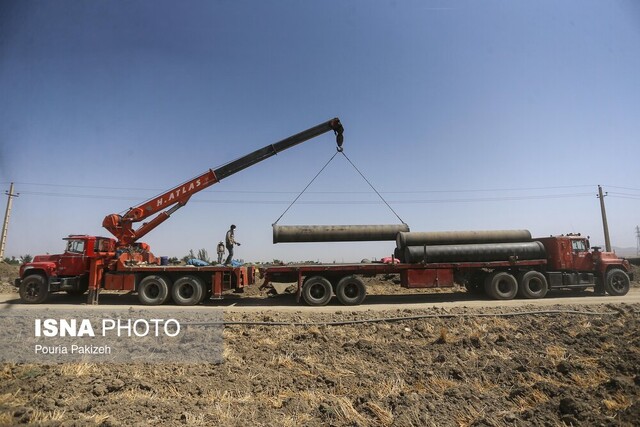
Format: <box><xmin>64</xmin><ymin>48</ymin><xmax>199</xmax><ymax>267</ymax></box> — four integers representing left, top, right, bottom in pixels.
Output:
<box><xmin>15</xmin><ymin>118</ymin><xmax>344</xmax><ymax>305</ymax></box>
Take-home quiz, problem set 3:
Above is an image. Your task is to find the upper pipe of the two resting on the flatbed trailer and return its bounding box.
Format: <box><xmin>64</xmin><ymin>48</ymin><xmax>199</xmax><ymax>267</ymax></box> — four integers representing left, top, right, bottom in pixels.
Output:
<box><xmin>396</xmin><ymin>230</ymin><xmax>531</xmax><ymax>248</ymax></box>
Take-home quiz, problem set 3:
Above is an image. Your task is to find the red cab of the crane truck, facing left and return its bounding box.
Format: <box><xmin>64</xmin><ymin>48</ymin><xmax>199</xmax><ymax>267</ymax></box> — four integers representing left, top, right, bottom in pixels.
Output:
<box><xmin>15</xmin><ymin>235</ymin><xmax>116</xmax><ymax>304</ymax></box>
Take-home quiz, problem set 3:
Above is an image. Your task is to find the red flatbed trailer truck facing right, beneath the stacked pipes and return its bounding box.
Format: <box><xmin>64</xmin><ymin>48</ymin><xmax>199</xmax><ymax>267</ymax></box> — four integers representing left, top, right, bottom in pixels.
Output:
<box><xmin>261</xmin><ymin>232</ymin><xmax>633</xmax><ymax>306</ymax></box>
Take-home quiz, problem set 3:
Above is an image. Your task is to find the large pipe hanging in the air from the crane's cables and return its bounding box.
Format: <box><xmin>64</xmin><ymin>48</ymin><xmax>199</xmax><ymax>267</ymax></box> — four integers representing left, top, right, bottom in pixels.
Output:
<box><xmin>273</xmin><ymin>224</ymin><xmax>409</xmax><ymax>243</ymax></box>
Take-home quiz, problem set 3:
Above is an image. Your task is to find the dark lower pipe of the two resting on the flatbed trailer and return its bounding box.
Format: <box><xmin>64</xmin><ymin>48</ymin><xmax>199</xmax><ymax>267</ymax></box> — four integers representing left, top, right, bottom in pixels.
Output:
<box><xmin>404</xmin><ymin>242</ymin><xmax>546</xmax><ymax>263</ymax></box>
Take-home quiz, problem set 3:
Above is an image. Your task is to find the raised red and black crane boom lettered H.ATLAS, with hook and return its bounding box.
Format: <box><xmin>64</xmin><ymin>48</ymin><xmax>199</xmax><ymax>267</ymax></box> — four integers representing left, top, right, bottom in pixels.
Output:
<box><xmin>102</xmin><ymin>118</ymin><xmax>344</xmax><ymax>246</ymax></box>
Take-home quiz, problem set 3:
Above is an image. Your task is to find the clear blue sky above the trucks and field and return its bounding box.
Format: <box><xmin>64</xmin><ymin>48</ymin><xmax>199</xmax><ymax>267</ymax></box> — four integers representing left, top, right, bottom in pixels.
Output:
<box><xmin>0</xmin><ymin>0</ymin><xmax>640</xmax><ymax>262</ymax></box>
